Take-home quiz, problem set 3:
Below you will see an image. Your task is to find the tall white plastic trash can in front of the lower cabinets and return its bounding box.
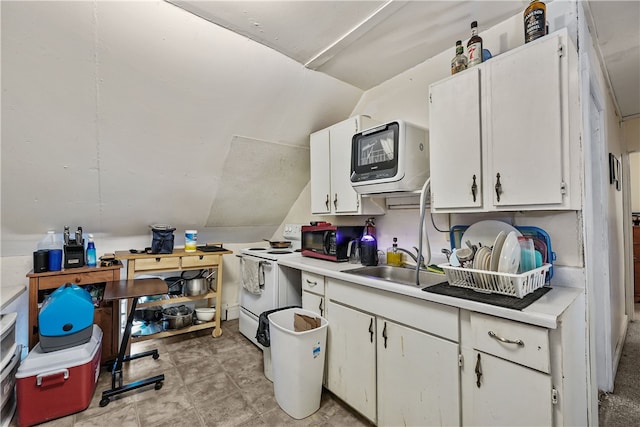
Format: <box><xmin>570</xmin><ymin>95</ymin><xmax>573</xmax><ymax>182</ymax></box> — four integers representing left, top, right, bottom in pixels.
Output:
<box><xmin>269</xmin><ymin>308</ymin><xmax>329</xmax><ymax>420</ymax></box>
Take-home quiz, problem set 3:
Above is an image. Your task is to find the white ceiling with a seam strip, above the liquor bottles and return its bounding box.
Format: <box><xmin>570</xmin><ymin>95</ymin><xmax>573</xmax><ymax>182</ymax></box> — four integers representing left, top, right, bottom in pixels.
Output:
<box><xmin>170</xmin><ymin>0</ymin><xmax>640</xmax><ymax>118</ymax></box>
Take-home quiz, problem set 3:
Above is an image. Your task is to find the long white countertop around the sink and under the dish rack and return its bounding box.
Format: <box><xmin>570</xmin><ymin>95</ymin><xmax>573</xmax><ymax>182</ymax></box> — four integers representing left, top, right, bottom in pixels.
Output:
<box><xmin>278</xmin><ymin>255</ymin><xmax>582</xmax><ymax>329</ymax></box>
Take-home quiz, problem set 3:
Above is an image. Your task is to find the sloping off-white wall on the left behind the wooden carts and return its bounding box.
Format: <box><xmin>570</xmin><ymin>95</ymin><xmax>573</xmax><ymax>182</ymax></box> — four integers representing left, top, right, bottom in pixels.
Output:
<box><xmin>0</xmin><ymin>1</ymin><xmax>370</xmax><ymax>328</ymax></box>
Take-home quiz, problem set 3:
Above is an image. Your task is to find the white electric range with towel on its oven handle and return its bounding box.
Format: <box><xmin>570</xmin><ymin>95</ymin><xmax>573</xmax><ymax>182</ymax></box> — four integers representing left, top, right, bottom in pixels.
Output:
<box><xmin>239</xmin><ymin>224</ymin><xmax>302</xmax><ymax>349</ymax></box>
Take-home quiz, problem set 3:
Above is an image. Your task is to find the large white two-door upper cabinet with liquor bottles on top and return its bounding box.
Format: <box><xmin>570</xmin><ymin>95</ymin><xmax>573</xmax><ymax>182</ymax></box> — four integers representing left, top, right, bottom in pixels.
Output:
<box><xmin>429</xmin><ymin>29</ymin><xmax>580</xmax><ymax>212</ymax></box>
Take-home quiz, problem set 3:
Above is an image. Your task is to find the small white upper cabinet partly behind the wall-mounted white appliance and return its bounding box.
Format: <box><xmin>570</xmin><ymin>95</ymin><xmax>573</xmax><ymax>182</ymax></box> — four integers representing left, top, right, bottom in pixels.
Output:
<box><xmin>309</xmin><ymin>116</ymin><xmax>384</xmax><ymax>215</ymax></box>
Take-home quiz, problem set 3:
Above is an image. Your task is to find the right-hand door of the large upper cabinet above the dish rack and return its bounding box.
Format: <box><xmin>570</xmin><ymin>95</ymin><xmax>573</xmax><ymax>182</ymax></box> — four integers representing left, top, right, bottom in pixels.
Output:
<box><xmin>485</xmin><ymin>36</ymin><xmax>567</xmax><ymax>207</ymax></box>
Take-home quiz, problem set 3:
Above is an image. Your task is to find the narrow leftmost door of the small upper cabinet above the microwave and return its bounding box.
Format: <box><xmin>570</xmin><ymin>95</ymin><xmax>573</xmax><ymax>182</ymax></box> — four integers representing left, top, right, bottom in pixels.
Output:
<box><xmin>309</xmin><ymin>129</ymin><xmax>331</xmax><ymax>214</ymax></box>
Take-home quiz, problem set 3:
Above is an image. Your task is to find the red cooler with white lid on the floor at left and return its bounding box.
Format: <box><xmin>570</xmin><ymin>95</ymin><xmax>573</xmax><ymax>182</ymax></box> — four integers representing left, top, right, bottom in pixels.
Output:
<box><xmin>16</xmin><ymin>325</ymin><xmax>102</xmax><ymax>427</ymax></box>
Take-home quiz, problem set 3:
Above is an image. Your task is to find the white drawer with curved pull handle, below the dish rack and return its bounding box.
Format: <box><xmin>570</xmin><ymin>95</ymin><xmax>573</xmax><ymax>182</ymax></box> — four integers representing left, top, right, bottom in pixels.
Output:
<box><xmin>471</xmin><ymin>313</ymin><xmax>550</xmax><ymax>373</ymax></box>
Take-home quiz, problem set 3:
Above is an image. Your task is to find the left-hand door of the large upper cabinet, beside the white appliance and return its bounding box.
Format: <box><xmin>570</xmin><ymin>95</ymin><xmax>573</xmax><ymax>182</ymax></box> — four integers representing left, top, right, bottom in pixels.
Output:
<box><xmin>429</xmin><ymin>67</ymin><xmax>482</xmax><ymax>210</ymax></box>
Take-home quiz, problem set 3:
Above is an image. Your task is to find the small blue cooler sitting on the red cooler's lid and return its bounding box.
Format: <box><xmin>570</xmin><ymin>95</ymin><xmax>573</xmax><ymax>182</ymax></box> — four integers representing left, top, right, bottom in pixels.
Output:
<box><xmin>38</xmin><ymin>283</ymin><xmax>94</xmax><ymax>353</ymax></box>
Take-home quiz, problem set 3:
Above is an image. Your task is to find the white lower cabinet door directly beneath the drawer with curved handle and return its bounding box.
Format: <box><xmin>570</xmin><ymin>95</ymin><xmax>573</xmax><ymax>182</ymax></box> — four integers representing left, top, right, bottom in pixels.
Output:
<box><xmin>462</xmin><ymin>349</ymin><xmax>553</xmax><ymax>426</ymax></box>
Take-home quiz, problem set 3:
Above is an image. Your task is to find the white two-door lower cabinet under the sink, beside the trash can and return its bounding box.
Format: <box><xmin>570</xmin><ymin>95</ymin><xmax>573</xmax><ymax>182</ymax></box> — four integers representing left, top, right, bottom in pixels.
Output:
<box><xmin>326</xmin><ymin>279</ymin><xmax>460</xmax><ymax>426</ymax></box>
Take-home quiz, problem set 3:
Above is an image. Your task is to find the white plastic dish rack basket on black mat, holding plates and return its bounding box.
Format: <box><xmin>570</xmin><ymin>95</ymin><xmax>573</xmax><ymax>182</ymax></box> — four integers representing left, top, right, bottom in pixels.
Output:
<box><xmin>438</xmin><ymin>263</ymin><xmax>551</xmax><ymax>298</ymax></box>
